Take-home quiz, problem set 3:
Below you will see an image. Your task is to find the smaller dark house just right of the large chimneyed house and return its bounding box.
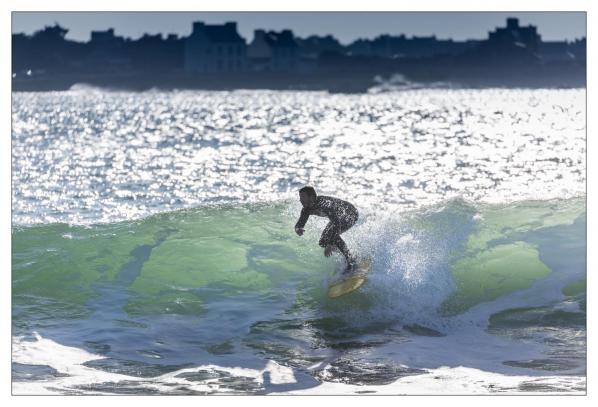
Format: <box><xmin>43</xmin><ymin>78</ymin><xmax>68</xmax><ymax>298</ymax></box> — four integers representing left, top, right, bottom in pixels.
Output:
<box><xmin>247</xmin><ymin>30</ymin><xmax>300</xmax><ymax>72</ymax></box>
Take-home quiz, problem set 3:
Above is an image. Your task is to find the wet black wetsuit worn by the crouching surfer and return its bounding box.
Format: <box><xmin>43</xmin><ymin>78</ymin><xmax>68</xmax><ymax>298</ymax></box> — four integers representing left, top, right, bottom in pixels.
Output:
<box><xmin>295</xmin><ymin>195</ymin><xmax>359</xmax><ymax>264</ymax></box>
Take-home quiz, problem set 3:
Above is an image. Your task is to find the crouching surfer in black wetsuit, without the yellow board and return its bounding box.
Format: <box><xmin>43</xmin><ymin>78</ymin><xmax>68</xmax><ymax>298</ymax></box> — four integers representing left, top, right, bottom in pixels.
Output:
<box><xmin>295</xmin><ymin>187</ymin><xmax>359</xmax><ymax>271</ymax></box>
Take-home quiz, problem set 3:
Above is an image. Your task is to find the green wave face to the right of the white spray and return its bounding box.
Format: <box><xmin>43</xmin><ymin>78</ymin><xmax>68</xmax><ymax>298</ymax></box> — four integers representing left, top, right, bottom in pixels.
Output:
<box><xmin>442</xmin><ymin>200</ymin><xmax>586</xmax><ymax>315</ymax></box>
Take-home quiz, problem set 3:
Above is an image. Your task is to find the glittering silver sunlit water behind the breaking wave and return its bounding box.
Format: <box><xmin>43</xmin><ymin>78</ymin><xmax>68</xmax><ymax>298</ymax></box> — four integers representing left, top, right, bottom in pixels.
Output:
<box><xmin>12</xmin><ymin>89</ymin><xmax>586</xmax><ymax>224</ymax></box>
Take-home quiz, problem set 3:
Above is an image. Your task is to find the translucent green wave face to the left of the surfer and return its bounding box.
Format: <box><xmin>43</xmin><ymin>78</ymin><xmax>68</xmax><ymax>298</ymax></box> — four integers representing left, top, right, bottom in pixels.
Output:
<box><xmin>12</xmin><ymin>205</ymin><xmax>330</xmax><ymax>320</ymax></box>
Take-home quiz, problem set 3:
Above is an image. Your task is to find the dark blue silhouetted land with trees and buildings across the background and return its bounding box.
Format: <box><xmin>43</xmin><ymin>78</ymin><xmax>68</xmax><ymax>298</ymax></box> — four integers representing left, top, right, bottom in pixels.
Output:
<box><xmin>12</xmin><ymin>18</ymin><xmax>586</xmax><ymax>90</ymax></box>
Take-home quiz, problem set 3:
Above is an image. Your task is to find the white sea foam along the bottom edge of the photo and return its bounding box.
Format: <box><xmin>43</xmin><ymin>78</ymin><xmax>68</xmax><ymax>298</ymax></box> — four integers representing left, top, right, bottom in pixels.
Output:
<box><xmin>12</xmin><ymin>335</ymin><xmax>586</xmax><ymax>395</ymax></box>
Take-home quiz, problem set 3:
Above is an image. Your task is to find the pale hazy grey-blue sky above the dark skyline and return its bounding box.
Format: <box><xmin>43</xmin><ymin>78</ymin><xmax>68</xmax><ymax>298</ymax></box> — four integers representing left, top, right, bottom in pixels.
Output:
<box><xmin>12</xmin><ymin>12</ymin><xmax>586</xmax><ymax>44</ymax></box>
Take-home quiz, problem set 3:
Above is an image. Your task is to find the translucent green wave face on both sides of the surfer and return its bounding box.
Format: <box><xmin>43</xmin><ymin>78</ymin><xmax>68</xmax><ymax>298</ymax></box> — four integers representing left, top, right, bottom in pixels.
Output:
<box><xmin>12</xmin><ymin>200</ymin><xmax>585</xmax><ymax>322</ymax></box>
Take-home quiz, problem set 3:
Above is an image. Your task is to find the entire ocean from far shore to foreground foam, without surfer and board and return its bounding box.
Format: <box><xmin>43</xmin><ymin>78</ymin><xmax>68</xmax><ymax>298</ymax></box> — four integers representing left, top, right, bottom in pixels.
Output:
<box><xmin>12</xmin><ymin>86</ymin><xmax>587</xmax><ymax>395</ymax></box>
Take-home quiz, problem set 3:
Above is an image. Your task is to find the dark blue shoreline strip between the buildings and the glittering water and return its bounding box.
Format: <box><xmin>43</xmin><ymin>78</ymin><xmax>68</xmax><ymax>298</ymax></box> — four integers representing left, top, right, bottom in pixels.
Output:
<box><xmin>12</xmin><ymin>69</ymin><xmax>586</xmax><ymax>93</ymax></box>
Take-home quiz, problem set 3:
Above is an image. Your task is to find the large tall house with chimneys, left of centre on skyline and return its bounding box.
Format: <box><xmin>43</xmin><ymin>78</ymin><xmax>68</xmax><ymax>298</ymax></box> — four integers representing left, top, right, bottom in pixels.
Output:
<box><xmin>184</xmin><ymin>22</ymin><xmax>247</xmax><ymax>73</ymax></box>
